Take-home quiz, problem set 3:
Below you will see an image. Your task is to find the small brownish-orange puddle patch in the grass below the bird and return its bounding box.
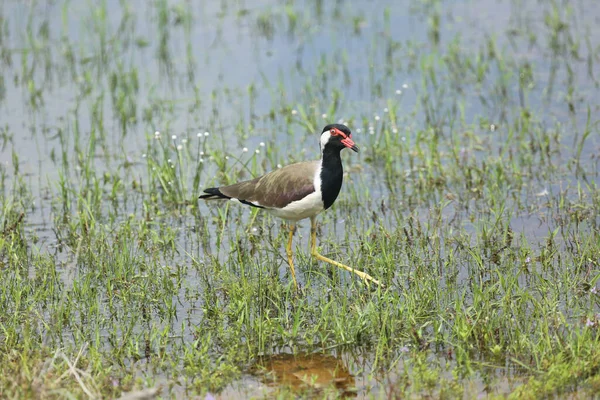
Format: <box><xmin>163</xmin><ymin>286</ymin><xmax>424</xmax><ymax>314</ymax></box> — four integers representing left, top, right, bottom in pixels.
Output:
<box><xmin>255</xmin><ymin>353</ymin><xmax>356</xmax><ymax>396</ymax></box>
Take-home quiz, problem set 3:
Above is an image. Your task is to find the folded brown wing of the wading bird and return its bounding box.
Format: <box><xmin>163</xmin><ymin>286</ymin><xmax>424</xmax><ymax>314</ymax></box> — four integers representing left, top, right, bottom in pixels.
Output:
<box><xmin>219</xmin><ymin>161</ymin><xmax>319</xmax><ymax>208</ymax></box>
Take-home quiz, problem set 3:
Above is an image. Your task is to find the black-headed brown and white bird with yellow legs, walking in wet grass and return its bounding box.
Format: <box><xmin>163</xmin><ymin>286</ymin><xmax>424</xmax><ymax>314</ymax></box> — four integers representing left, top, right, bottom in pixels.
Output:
<box><xmin>199</xmin><ymin>124</ymin><xmax>383</xmax><ymax>288</ymax></box>
